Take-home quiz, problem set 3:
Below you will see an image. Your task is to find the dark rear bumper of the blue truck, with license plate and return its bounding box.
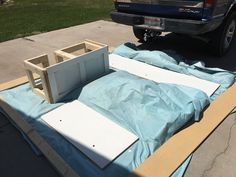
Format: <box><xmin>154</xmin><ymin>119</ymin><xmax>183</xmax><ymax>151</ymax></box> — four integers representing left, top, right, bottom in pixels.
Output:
<box><xmin>111</xmin><ymin>11</ymin><xmax>223</xmax><ymax>35</ymax></box>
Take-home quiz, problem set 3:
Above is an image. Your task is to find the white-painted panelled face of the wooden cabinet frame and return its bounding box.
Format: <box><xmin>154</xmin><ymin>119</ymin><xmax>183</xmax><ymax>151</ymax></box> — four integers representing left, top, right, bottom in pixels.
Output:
<box><xmin>47</xmin><ymin>47</ymin><xmax>109</xmax><ymax>102</ymax></box>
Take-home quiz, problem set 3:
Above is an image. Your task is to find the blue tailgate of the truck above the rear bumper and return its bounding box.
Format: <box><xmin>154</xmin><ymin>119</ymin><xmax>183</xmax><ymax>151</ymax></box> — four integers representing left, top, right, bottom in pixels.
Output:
<box><xmin>115</xmin><ymin>0</ymin><xmax>204</xmax><ymax>19</ymax></box>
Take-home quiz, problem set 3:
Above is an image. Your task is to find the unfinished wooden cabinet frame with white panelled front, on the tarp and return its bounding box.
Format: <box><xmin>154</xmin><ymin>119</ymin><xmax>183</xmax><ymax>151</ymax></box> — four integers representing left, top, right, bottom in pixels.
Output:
<box><xmin>24</xmin><ymin>40</ymin><xmax>109</xmax><ymax>103</ymax></box>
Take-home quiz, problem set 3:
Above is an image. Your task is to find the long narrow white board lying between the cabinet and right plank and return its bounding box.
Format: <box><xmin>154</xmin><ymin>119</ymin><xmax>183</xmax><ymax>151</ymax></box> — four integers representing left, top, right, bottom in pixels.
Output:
<box><xmin>109</xmin><ymin>54</ymin><xmax>220</xmax><ymax>96</ymax></box>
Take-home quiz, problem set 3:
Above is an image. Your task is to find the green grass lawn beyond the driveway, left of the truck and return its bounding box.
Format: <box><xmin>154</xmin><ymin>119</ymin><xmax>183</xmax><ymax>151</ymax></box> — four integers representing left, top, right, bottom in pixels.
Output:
<box><xmin>0</xmin><ymin>0</ymin><xmax>113</xmax><ymax>42</ymax></box>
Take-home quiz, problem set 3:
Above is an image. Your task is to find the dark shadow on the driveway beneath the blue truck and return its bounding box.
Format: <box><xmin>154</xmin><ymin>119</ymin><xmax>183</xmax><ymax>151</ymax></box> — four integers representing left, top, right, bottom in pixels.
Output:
<box><xmin>138</xmin><ymin>33</ymin><xmax>236</xmax><ymax>71</ymax></box>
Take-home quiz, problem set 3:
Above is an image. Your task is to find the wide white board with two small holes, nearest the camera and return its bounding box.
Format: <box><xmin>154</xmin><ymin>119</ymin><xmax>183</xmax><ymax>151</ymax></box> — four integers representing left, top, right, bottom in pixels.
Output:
<box><xmin>42</xmin><ymin>100</ymin><xmax>138</xmax><ymax>168</ymax></box>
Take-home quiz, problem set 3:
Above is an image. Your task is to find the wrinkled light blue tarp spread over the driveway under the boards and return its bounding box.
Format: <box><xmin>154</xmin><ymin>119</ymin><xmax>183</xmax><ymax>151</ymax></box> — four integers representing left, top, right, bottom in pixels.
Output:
<box><xmin>0</xmin><ymin>45</ymin><xmax>235</xmax><ymax>177</ymax></box>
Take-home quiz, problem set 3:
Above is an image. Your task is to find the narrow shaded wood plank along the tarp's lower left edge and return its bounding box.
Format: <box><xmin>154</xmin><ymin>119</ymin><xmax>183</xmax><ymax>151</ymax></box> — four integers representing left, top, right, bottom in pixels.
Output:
<box><xmin>0</xmin><ymin>97</ymin><xmax>79</xmax><ymax>177</ymax></box>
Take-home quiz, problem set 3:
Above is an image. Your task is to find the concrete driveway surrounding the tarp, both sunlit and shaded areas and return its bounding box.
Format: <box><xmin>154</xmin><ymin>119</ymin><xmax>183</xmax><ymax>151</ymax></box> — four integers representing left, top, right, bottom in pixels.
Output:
<box><xmin>0</xmin><ymin>21</ymin><xmax>236</xmax><ymax>177</ymax></box>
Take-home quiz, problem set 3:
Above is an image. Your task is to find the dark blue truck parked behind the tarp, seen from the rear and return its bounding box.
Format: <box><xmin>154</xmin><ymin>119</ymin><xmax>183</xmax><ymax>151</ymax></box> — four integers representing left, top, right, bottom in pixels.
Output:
<box><xmin>111</xmin><ymin>0</ymin><xmax>236</xmax><ymax>56</ymax></box>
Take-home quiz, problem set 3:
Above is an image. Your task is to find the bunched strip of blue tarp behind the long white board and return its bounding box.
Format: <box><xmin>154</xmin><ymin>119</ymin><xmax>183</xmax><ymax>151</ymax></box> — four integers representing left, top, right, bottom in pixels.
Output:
<box><xmin>112</xmin><ymin>43</ymin><xmax>236</xmax><ymax>100</ymax></box>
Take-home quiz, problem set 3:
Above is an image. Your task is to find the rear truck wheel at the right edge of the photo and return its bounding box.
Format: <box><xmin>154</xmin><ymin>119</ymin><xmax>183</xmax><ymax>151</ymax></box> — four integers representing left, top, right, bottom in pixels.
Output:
<box><xmin>212</xmin><ymin>13</ymin><xmax>236</xmax><ymax>56</ymax></box>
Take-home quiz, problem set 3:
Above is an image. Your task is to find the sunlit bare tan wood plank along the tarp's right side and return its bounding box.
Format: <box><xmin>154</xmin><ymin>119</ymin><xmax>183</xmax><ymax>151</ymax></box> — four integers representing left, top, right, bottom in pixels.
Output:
<box><xmin>129</xmin><ymin>84</ymin><xmax>236</xmax><ymax>177</ymax></box>
